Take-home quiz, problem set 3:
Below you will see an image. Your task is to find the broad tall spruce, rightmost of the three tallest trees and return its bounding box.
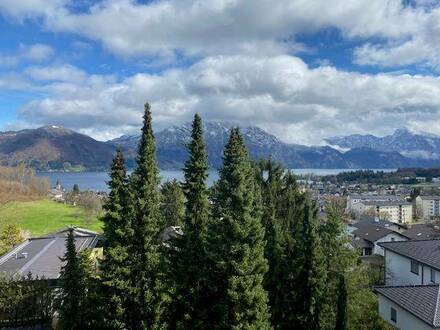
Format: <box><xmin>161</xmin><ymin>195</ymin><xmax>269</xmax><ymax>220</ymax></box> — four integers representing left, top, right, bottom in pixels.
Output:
<box><xmin>208</xmin><ymin>128</ymin><xmax>270</xmax><ymax>329</ymax></box>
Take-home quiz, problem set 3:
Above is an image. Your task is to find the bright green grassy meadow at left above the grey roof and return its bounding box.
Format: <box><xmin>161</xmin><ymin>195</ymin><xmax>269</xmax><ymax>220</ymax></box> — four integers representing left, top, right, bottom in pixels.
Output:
<box><xmin>0</xmin><ymin>199</ymin><xmax>102</xmax><ymax>237</ymax></box>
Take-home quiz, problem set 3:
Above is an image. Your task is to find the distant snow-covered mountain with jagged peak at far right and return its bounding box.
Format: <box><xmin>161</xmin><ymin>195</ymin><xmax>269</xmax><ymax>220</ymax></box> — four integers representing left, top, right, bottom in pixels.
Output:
<box><xmin>326</xmin><ymin>128</ymin><xmax>440</xmax><ymax>161</ymax></box>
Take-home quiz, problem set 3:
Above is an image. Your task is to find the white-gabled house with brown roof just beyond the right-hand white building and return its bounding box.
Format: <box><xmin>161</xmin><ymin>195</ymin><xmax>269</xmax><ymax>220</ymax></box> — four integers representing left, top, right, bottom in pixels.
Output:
<box><xmin>351</xmin><ymin>222</ymin><xmax>408</xmax><ymax>256</ymax></box>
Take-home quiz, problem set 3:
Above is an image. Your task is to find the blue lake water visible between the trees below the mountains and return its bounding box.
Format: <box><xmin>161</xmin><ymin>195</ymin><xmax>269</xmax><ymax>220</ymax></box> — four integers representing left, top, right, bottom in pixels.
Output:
<box><xmin>38</xmin><ymin>168</ymin><xmax>395</xmax><ymax>191</ymax></box>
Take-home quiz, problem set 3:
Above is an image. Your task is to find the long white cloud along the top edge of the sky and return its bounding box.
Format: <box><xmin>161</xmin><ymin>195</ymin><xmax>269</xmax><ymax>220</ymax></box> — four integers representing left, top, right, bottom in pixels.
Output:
<box><xmin>0</xmin><ymin>0</ymin><xmax>434</xmax><ymax>65</ymax></box>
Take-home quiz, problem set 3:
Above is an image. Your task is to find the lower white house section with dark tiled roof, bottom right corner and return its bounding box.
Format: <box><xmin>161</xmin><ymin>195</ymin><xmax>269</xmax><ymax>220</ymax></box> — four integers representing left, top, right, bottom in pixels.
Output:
<box><xmin>375</xmin><ymin>284</ymin><xmax>440</xmax><ymax>330</ymax></box>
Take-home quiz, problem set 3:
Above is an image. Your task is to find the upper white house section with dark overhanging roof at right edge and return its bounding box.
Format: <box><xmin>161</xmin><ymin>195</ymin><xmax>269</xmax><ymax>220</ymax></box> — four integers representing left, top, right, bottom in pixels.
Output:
<box><xmin>378</xmin><ymin>239</ymin><xmax>440</xmax><ymax>286</ymax></box>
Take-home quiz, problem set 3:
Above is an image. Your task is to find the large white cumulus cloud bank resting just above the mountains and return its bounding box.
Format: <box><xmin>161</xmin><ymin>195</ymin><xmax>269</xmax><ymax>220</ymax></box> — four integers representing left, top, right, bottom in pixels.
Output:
<box><xmin>15</xmin><ymin>55</ymin><xmax>440</xmax><ymax>144</ymax></box>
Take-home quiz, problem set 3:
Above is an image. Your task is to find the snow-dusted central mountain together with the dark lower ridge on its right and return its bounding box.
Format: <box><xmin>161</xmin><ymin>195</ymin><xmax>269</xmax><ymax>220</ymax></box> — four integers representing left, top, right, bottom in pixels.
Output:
<box><xmin>108</xmin><ymin>122</ymin><xmax>430</xmax><ymax>169</ymax></box>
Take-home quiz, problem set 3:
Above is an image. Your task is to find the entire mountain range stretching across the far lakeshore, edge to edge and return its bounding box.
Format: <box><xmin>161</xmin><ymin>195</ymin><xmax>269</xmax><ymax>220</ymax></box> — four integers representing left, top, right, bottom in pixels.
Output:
<box><xmin>0</xmin><ymin>122</ymin><xmax>440</xmax><ymax>170</ymax></box>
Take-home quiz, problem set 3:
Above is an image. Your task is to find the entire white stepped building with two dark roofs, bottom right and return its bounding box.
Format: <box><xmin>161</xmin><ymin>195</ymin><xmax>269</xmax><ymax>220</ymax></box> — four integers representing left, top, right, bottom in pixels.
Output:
<box><xmin>375</xmin><ymin>239</ymin><xmax>440</xmax><ymax>330</ymax></box>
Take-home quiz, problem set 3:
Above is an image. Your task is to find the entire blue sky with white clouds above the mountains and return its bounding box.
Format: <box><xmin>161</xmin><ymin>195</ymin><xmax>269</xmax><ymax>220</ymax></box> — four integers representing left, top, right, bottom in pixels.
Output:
<box><xmin>0</xmin><ymin>0</ymin><xmax>440</xmax><ymax>145</ymax></box>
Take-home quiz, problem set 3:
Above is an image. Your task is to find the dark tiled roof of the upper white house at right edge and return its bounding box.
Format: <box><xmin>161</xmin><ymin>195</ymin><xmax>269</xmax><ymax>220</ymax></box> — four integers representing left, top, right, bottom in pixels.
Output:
<box><xmin>378</xmin><ymin>239</ymin><xmax>440</xmax><ymax>270</ymax></box>
